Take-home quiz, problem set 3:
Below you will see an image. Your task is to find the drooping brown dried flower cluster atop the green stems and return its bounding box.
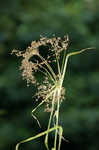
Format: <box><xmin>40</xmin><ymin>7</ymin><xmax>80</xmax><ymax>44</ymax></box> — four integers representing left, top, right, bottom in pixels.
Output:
<box><xmin>12</xmin><ymin>36</ymin><xmax>69</xmax><ymax>111</ymax></box>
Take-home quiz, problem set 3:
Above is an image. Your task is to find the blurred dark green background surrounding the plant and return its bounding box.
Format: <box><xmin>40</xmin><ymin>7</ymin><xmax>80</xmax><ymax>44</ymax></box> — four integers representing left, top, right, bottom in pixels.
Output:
<box><xmin>0</xmin><ymin>0</ymin><xmax>99</xmax><ymax>150</ymax></box>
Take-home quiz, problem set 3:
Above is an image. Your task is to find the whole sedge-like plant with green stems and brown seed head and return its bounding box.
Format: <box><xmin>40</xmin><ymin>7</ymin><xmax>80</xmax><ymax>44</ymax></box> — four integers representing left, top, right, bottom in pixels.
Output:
<box><xmin>12</xmin><ymin>36</ymin><xmax>92</xmax><ymax>150</ymax></box>
